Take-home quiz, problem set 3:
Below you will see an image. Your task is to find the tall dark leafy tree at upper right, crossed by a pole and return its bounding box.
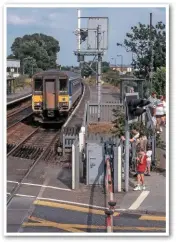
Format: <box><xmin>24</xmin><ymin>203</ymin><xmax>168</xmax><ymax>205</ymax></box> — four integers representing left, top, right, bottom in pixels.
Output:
<box><xmin>124</xmin><ymin>22</ymin><xmax>166</xmax><ymax>78</ymax></box>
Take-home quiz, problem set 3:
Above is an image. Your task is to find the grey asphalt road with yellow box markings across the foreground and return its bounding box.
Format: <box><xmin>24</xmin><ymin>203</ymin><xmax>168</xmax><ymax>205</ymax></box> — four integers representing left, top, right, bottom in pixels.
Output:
<box><xmin>7</xmin><ymin>197</ymin><xmax>166</xmax><ymax>233</ymax></box>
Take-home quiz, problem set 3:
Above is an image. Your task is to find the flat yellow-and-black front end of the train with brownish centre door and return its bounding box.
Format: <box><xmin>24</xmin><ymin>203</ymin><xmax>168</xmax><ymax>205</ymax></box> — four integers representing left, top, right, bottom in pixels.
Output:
<box><xmin>32</xmin><ymin>75</ymin><xmax>69</xmax><ymax>122</ymax></box>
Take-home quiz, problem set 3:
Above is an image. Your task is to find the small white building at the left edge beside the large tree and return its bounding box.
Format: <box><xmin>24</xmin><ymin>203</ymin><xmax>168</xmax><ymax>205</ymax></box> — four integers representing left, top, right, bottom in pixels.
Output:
<box><xmin>6</xmin><ymin>59</ymin><xmax>20</xmax><ymax>77</ymax></box>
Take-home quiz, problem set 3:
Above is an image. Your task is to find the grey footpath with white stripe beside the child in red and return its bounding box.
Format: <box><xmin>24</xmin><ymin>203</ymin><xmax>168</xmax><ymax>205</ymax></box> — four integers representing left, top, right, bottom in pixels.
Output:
<box><xmin>120</xmin><ymin>128</ymin><xmax>166</xmax><ymax>214</ymax></box>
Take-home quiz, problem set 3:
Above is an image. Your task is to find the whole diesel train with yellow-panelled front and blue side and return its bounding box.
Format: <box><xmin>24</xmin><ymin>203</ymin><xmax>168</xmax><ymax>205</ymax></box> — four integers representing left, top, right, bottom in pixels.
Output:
<box><xmin>32</xmin><ymin>70</ymin><xmax>83</xmax><ymax>123</ymax></box>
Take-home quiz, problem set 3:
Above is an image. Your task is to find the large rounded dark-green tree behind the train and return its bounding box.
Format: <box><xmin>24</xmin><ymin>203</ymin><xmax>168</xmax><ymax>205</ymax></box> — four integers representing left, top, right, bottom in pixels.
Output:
<box><xmin>11</xmin><ymin>33</ymin><xmax>60</xmax><ymax>74</ymax></box>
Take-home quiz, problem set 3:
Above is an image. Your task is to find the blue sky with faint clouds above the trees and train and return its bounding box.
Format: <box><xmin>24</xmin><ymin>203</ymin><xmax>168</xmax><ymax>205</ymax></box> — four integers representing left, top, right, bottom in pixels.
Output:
<box><xmin>7</xmin><ymin>7</ymin><xmax>166</xmax><ymax>66</ymax></box>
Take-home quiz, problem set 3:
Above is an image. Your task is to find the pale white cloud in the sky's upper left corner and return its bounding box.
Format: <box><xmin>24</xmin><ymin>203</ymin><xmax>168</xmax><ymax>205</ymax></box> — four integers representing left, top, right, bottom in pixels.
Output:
<box><xmin>7</xmin><ymin>14</ymin><xmax>36</xmax><ymax>25</ymax></box>
